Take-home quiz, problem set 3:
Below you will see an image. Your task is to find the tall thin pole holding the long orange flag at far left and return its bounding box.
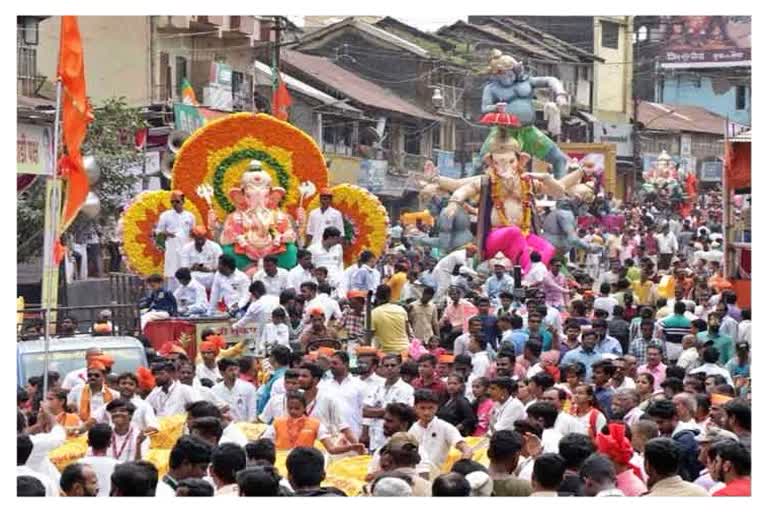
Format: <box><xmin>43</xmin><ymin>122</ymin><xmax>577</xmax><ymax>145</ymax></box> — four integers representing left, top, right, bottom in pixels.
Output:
<box><xmin>42</xmin><ymin>78</ymin><xmax>62</xmax><ymax>397</ymax></box>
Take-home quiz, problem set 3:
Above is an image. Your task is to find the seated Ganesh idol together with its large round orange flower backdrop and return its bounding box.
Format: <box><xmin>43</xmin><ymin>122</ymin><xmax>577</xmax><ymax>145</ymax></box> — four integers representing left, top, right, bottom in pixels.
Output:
<box><xmin>172</xmin><ymin>113</ymin><xmax>328</xmax><ymax>273</ymax></box>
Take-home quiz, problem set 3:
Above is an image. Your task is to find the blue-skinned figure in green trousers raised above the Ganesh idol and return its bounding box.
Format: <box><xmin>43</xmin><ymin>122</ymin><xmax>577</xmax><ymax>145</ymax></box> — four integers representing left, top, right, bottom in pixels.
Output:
<box><xmin>480</xmin><ymin>50</ymin><xmax>568</xmax><ymax>178</ymax></box>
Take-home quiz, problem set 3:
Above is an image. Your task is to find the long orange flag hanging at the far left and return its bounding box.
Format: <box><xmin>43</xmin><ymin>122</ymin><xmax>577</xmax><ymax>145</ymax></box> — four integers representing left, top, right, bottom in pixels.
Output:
<box><xmin>57</xmin><ymin>16</ymin><xmax>93</xmax><ymax>232</ymax></box>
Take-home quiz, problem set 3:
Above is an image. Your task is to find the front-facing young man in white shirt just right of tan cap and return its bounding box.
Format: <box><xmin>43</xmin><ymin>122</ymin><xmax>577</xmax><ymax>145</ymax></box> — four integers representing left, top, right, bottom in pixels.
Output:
<box><xmin>408</xmin><ymin>389</ymin><xmax>472</xmax><ymax>474</ymax></box>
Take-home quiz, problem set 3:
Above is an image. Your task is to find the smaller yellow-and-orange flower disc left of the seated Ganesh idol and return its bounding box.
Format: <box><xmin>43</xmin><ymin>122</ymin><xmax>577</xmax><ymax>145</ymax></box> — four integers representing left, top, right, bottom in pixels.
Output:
<box><xmin>120</xmin><ymin>190</ymin><xmax>203</xmax><ymax>277</ymax></box>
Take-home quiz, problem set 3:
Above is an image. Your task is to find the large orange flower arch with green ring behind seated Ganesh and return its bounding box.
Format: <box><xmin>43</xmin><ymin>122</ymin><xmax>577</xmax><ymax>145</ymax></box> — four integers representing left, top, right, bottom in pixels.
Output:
<box><xmin>172</xmin><ymin>113</ymin><xmax>328</xmax><ymax>221</ymax></box>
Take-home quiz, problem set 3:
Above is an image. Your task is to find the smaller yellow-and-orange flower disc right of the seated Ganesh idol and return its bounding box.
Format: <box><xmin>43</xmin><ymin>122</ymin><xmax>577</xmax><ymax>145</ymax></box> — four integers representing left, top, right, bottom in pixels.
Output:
<box><xmin>307</xmin><ymin>183</ymin><xmax>389</xmax><ymax>265</ymax></box>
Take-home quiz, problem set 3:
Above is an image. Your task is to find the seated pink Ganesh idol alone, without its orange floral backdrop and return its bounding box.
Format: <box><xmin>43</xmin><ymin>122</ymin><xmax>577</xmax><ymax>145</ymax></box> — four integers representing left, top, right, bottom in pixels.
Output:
<box><xmin>219</xmin><ymin>160</ymin><xmax>296</xmax><ymax>269</ymax></box>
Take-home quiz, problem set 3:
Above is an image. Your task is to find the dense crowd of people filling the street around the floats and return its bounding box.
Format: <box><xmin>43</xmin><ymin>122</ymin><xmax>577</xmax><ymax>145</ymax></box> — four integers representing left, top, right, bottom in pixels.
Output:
<box><xmin>17</xmin><ymin>186</ymin><xmax>751</xmax><ymax>496</ymax></box>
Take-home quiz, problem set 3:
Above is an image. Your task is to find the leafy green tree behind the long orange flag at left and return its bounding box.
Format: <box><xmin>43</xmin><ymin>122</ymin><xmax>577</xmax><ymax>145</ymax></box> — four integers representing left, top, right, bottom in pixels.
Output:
<box><xmin>16</xmin><ymin>97</ymin><xmax>148</xmax><ymax>262</ymax></box>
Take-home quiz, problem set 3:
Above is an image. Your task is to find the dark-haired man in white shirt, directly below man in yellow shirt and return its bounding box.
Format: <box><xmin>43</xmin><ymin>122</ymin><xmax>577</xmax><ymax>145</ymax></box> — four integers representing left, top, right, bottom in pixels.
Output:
<box><xmin>358</xmin><ymin>354</ymin><xmax>413</xmax><ymax>451</ymax></box>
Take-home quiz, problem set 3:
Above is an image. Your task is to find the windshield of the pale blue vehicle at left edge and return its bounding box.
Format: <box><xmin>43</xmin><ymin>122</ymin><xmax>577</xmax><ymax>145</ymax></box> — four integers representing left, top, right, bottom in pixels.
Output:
<box><xmin>21</xmin><ymin>347</ymin><xmax>144</xmax><ymax>380</ymax></box>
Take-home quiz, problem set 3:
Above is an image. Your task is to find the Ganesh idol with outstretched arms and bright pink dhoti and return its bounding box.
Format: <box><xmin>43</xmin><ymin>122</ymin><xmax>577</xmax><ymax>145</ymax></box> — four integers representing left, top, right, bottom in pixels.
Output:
<box><xmin>425</xmin><ymin>129</ymin><xmax>594</xmax><ymax>270</ymax></box>
